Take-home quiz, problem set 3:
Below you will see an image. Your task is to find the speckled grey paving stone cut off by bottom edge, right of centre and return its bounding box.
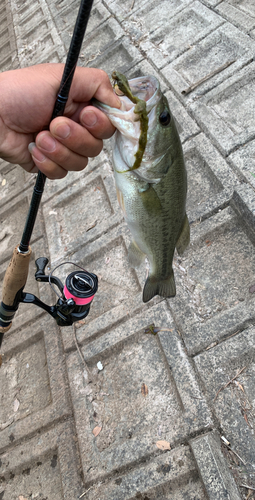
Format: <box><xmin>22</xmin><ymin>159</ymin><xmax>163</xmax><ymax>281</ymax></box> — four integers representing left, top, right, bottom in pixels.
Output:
<box><xmin>82</xmin><ymin>446</ymin><xmax>208</xmax><ymax>500</ymax></box>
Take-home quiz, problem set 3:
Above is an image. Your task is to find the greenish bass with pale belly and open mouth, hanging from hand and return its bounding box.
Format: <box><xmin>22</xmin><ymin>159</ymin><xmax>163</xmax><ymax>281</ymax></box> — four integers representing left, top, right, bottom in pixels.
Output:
<box><xmin>93</xmin><ymin>72</ymin><xmax>190</xmax><ymax>302</ymax></box>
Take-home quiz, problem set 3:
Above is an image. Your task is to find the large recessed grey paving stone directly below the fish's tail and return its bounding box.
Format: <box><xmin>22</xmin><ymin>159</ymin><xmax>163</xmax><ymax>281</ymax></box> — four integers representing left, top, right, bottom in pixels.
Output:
<box><xmin>67</xmin><ymin>304</ymin><xmax>212</xmax><ymax>483</ymax></box>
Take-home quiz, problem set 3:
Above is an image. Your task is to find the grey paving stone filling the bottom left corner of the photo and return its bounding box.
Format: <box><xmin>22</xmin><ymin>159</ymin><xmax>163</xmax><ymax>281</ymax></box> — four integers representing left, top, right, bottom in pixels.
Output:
<box><xmin>0</xmin><ymin>421</ymin><xmax>82</xmax><ymax>500</ymax></box>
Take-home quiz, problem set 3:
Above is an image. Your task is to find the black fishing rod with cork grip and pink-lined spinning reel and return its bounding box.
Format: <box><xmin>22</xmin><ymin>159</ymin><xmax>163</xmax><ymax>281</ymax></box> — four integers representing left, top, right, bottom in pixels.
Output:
<box><xmin>0</xmin><ymin>0</ymin><xmax>98</xmax><ymax>346</ymax></box>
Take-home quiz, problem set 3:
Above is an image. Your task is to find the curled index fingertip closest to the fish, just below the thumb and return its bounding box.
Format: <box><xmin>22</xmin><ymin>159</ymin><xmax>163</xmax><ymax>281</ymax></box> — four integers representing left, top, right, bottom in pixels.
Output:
<box><xmin>80</xmin><ymin>106</ymin><xmax>116</xmax><ymax>139</ymax></box>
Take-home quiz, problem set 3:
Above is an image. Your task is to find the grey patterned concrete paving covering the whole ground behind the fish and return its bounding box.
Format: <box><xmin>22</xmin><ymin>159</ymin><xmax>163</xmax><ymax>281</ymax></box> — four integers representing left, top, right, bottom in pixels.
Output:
<box><xmin>0</xmin><ymin>0</ymin><xmax>255</xmax><ymax>500</ymax></box>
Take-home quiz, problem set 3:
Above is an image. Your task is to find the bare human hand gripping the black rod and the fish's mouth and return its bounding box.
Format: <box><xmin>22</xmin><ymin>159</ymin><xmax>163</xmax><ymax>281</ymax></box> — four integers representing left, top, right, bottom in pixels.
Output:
<box><xmin>0</xmin><ymin>64</ymin><xmax>120</xmax><ymax>179</ymax></box>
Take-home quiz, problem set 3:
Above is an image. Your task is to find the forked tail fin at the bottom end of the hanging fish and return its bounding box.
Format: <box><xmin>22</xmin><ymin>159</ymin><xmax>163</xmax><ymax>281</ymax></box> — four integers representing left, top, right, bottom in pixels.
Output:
<box><xmin>143</xmin><ymin>271</ymin><xmax>176</xmax><ymax>302</ymax></box>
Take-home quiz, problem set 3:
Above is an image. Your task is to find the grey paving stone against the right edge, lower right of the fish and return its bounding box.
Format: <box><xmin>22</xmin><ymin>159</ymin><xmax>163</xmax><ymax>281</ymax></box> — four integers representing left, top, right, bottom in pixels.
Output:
<box><xmin>194</xmin><ymin>327</ymin><xmax>255</xmax><ymax>487</ymax></box>
